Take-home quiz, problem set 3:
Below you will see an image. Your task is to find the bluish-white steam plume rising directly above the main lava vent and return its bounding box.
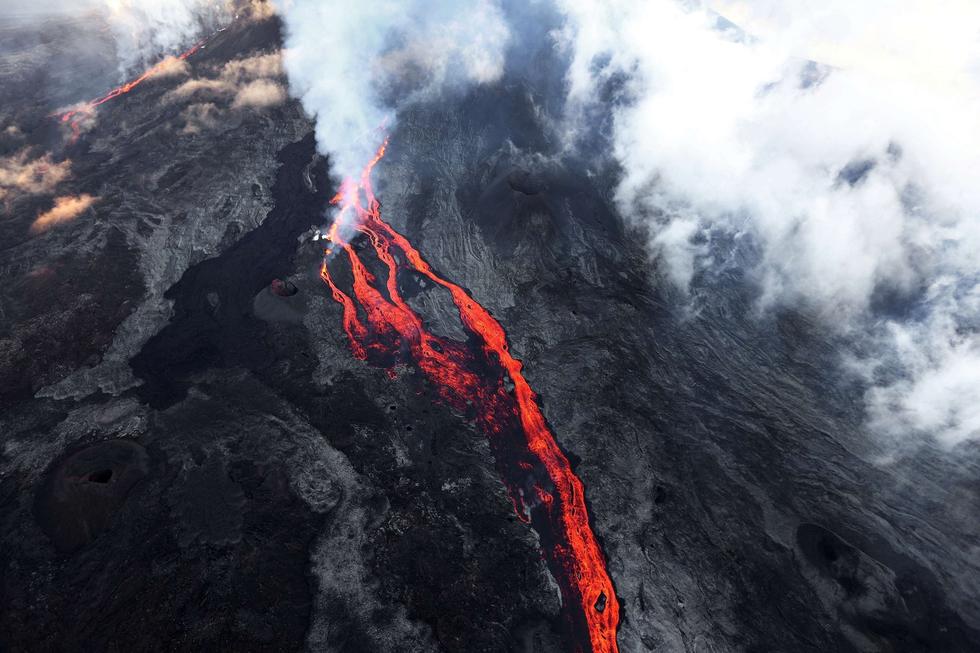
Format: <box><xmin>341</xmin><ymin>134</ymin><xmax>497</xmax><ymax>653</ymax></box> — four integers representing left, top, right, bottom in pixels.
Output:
<box><xmin>279</xmin><ymin>0</ymin><xmax>509</xmax><ymax>176</ymax></box>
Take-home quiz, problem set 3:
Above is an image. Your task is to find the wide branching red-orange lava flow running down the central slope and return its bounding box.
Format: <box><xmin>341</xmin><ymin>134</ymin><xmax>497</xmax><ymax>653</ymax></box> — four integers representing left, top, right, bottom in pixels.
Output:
<box><xmin>320</xmin><ymin>140</ymin><xmax>619</xmax><ymax>653</ymax></box>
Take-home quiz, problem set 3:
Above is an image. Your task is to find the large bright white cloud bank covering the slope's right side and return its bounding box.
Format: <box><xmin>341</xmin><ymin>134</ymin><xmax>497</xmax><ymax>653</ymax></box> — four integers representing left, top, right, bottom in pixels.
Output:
<box><xmin>558</xmin><ymin>0</ymin><xmax>980</xmax><ymax>445</ymax></box>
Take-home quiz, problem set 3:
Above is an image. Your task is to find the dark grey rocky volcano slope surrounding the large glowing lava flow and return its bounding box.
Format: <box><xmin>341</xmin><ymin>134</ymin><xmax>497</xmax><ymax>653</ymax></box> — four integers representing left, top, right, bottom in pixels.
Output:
<box><xmin>0</xmin><ymin>9</ymin><xmax>980</xmax><ymax>652</ymax></box>
